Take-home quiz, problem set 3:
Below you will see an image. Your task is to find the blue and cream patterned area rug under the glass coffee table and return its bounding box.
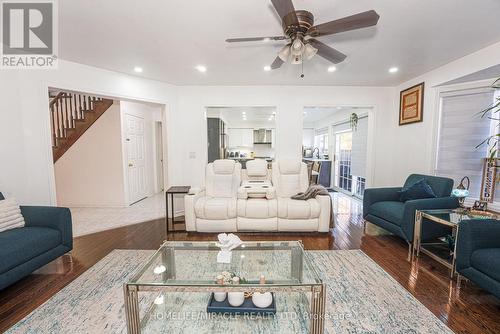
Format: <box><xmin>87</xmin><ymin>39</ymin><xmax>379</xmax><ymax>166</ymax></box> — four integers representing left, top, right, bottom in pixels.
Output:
<box><xmin>7</xmin><ymin>250</ymin><xmax>452</xmax><ymax>334</ymax></box>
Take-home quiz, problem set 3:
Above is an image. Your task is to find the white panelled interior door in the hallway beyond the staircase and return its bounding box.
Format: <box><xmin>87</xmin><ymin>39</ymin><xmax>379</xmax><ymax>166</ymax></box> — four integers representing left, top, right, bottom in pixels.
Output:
<box><xmin>125</xmin><ymin>114</ymin><xmax>147</xmax><ymax>204</ymax></box>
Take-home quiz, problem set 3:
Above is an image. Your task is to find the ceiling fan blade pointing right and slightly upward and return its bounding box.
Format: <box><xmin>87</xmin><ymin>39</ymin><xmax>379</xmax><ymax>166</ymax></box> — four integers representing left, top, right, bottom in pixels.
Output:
<box><xmin>307</xmin><ymin>10</ymin><xmax>380</xmax><ymax>37</ymax></box>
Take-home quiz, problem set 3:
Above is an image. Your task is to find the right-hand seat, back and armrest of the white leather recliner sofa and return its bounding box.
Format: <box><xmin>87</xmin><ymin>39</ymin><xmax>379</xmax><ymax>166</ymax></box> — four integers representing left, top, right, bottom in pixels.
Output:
<box><xmin>272</xmin><ymin>159</ymin><xmax>331</xmax><ymax>232</ymax></box>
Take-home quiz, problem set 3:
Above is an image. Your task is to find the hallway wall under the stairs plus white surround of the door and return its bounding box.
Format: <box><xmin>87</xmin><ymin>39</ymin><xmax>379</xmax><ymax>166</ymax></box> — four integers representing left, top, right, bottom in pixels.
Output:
<box><xmin>54</xmin><ymin>100</ymin><xmax>162</xmax><ymax>207</ymax></box>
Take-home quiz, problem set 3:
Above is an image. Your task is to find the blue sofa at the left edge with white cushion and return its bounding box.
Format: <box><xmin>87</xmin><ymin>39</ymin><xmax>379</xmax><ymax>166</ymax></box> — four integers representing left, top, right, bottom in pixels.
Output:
<box><xmin>0</xmin><ymin>193</ymin><xmax>73</xmax><ymax>290</ymax></box>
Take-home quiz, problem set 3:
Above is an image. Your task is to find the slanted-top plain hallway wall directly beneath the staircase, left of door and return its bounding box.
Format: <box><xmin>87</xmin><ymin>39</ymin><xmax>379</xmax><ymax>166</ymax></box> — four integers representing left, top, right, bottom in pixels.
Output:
<box><xmin>54</xmin><ymin>102</ymin><xmax>127</xmax><ymax>207</ymax></box>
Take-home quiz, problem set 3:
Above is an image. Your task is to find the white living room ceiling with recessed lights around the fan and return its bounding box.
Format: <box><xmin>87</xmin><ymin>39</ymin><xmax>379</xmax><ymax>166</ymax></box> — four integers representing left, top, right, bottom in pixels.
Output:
<box><xmin>58</xmin><ymin>0</ymin><xmax>500</xmax><ymax>86</ymax></box>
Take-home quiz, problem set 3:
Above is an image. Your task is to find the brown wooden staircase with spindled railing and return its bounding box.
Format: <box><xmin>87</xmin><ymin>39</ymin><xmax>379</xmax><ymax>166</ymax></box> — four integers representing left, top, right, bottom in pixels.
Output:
<box><xmin>49</xmin><ymin>92</ymin><xmax>113</xmax><ymax>163</ymax></box>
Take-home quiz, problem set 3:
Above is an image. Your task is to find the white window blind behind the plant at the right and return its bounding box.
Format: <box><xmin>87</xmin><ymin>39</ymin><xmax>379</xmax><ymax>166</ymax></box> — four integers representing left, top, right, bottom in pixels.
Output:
<box><xmin>436</xmin><ymin>89</ymin><xmax>494</xmax><ymax>198</ymax></box>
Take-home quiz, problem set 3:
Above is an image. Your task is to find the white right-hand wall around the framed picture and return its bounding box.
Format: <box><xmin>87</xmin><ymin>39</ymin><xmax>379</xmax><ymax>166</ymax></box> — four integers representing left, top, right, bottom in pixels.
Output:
<box><xmin>375</xmin><ymin>43</ymin><xmax>500</xmax><ymax>185</ymax></box>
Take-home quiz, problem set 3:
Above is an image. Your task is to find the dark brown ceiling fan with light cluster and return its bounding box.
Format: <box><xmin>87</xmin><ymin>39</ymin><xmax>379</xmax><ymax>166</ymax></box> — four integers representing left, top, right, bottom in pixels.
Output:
<box><xmin>226</xmin><ymin>0</ymin><xmax>380</xmax><ymax>70</ymax></box>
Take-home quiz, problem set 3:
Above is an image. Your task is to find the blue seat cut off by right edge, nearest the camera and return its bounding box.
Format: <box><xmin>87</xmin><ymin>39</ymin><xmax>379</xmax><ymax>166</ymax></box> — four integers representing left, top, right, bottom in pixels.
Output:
<box><xmin>456</xmin><ymin>219</ymin><xmax>500</xmax><ymax>299</ymax></box>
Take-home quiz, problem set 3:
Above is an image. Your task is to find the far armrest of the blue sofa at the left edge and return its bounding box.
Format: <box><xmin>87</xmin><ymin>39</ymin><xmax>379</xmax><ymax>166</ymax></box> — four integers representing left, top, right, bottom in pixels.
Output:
<box><xmin>21</xmin><ymin>206</ymin><xmax>73</xmax><ymax>249</ymax></box>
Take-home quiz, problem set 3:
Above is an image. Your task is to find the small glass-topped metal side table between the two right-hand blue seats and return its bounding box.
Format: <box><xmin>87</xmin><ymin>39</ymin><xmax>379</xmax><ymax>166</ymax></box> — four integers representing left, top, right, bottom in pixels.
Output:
<box><xmin>412</xmin><ymin>208</ymin><xmax>500</xmax><ymax>279</ymax></box>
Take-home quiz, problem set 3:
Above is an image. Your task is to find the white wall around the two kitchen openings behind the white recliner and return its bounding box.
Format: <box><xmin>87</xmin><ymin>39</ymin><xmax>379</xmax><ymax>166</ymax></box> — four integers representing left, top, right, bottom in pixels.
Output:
<box><xmin>170</xmin><ymin>86</ymin><xmax>394</xmax><ymax>186</ymax></box>
